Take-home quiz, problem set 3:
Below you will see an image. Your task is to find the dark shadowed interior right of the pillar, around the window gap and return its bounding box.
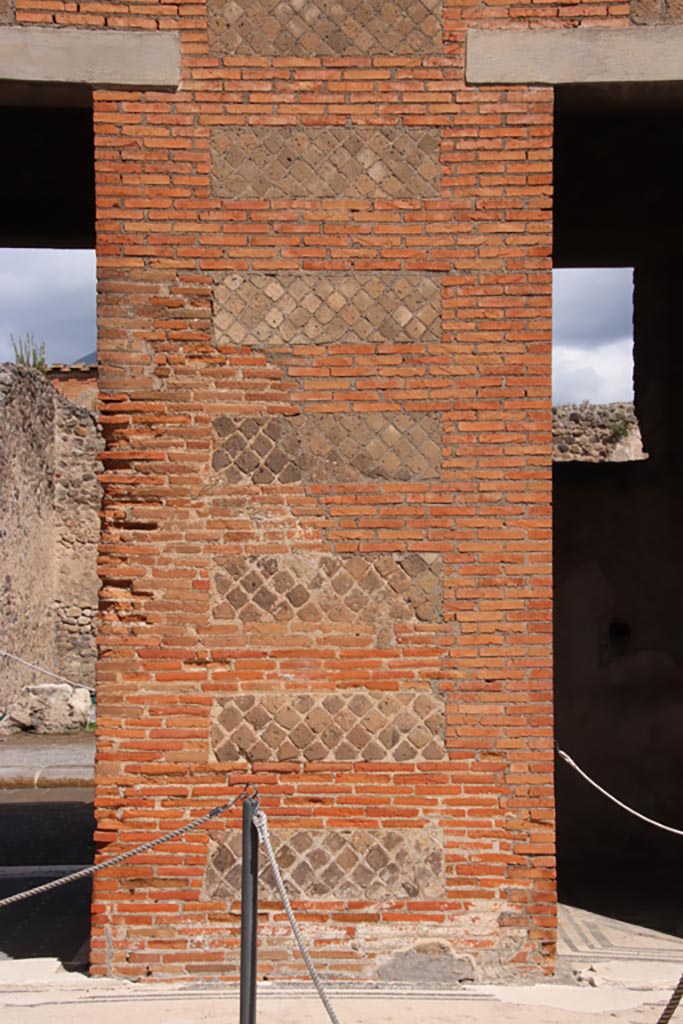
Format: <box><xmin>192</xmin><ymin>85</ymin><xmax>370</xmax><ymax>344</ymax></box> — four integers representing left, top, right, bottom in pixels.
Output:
<box><xmin>553</xmin><ymin>85</ymin><xmax>683</xmax><ymax>934</ymax></box>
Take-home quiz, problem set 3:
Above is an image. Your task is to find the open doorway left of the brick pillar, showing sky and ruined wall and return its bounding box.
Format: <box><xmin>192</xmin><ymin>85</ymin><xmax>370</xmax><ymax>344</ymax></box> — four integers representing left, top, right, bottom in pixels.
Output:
<box><xmin>0</xmin><ymin>90</ymin><xmax>98</xmax><ymax>969</ymax></box>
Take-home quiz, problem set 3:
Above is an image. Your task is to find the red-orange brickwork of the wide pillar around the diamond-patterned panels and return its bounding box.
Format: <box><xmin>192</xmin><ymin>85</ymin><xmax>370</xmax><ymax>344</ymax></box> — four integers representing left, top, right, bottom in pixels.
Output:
<box><xmin>9</xmin><ymin>0</ymin><xmax>593</xmax><ymax>980</ymax></box>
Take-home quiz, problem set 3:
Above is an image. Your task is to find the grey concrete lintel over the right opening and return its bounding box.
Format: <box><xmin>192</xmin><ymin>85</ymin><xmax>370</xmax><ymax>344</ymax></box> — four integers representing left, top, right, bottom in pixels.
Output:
<box><xmin>466</xmin><ymin>25</ymin><xmax>683</xmax><ymax>85</ymax></box>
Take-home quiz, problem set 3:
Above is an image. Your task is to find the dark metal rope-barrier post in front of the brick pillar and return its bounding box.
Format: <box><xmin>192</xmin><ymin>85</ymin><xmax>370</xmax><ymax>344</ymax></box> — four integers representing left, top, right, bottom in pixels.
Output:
<box><xmin>240</xmin><ymin>797</ymin><xmax>258</xmax><ymax>1024</ymax></box>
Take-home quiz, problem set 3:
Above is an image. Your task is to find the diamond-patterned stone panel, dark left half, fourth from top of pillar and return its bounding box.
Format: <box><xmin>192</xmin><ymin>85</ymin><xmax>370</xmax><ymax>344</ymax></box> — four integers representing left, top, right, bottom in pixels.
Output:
<box><xmin>212</xmin><ymin>413</ymin><xmax>441</xmax><ymax>484</ymax></box>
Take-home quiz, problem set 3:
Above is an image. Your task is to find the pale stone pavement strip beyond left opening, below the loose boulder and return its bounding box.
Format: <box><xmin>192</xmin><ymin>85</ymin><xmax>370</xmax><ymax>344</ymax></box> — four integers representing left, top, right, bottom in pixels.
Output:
<box><xmin>0</xmin><ymin>732</ymin><xmax>95</xmax><ymax>800</ymax></box>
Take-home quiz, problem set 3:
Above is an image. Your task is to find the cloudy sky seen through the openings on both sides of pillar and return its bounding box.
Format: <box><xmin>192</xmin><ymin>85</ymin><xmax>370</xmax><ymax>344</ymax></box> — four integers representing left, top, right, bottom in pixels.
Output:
<box><xmin>0</xmin><ymin>249</ymin><xmax>633</xmax><ymax>404</ymax></box>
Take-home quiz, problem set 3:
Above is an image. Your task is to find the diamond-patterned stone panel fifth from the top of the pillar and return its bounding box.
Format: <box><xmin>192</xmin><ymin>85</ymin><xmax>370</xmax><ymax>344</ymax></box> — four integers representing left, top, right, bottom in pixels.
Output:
<box><xmin>213</xmin><ymin>552</ymin><xmax>442</xmax><ymax>628</ymax></box>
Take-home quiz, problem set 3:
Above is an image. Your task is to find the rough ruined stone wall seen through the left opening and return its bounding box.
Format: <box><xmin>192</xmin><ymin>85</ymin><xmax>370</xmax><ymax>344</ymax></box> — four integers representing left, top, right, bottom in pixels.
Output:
<box><xmin>0</xmin><ymin>365</ymin><xmax>101</xmax><ymax>707</ymax></box>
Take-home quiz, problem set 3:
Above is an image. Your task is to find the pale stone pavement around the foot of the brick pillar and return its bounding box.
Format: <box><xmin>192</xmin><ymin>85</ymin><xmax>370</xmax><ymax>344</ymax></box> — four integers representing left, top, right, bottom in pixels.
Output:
<box><xmin>0</xmin><ymin>907</ymin><xmax>683</xmax><ymax>1024</ymax></box>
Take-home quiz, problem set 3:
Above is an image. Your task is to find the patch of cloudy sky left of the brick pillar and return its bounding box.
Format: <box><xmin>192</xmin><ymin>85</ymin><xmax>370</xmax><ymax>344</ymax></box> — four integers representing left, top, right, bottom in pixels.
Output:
<box><xmin>0</xmin><ymin>249</ymin><xmax>97</xmax><ymax>362</ymax></box>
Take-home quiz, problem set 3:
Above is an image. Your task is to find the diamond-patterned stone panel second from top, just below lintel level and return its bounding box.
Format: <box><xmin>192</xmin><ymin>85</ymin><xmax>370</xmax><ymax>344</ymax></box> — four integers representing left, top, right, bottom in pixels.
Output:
<box><xmin>211</xmin><ymin>126</ymin><xmax>440</xmax><ymax>200</ymax></box>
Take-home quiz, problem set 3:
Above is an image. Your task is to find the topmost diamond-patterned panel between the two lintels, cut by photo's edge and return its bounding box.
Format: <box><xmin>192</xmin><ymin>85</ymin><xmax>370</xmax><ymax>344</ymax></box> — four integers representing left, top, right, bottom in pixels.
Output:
<box><xmin>207</xmin><ymin>0</ymin><xmax>441</xmax><ymax>56</ymax></box>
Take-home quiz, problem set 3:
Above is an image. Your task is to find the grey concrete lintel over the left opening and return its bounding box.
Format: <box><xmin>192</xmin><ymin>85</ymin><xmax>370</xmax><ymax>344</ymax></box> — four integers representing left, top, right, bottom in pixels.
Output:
<box><xmin>0</xmin><ymin>26</ymin><xmax>180</xmax><ymax>89</ymax></box>
